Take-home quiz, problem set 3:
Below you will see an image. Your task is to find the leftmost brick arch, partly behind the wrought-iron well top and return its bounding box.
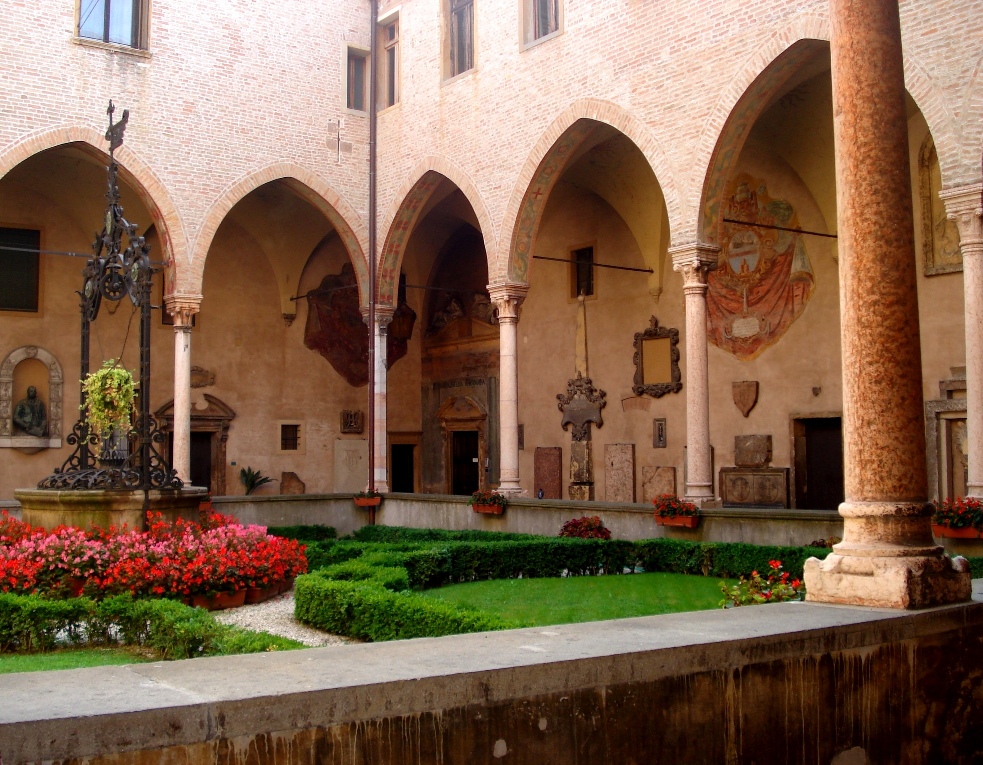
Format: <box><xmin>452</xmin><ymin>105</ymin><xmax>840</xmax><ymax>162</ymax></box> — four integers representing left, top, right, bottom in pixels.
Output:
<box><xmin>0</xmin><ymin>125</ymin><xmax>188</xmax><ymax>284</ymax></box>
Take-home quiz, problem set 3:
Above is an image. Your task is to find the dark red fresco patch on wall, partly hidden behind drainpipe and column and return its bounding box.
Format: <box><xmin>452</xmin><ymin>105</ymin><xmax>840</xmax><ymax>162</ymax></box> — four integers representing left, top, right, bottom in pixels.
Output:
<box><xmin>304</xmin><ymin>263</ymin><xmax>416</xmax><ymax>388</ymax></box>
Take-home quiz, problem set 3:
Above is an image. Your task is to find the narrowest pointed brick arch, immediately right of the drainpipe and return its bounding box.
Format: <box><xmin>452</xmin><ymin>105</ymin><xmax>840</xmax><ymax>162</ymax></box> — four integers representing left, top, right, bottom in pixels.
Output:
<box><xmin>378</xmin><ymin>156</ymin><xmax>496</xmax><ymax>305</ymax></box>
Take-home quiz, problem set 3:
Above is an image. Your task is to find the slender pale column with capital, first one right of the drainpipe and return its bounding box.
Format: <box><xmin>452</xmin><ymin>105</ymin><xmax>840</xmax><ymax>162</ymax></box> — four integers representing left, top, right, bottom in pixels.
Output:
<box><xmin>488</xmin><ymin>283</ymin><xmax>529</xmax><ymax>494</ymax></box>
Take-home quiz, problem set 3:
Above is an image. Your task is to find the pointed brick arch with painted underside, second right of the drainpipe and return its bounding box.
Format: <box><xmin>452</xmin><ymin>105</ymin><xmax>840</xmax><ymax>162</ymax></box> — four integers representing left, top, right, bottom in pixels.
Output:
<box><xmin>504</xmin><ymin>98</ymin><xmax>681</xmax><ymax>284</ymax></box>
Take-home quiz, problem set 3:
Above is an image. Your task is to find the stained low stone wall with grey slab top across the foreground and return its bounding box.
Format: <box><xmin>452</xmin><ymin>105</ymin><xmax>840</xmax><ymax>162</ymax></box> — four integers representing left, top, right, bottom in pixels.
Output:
<box><xmin>0</xmin><ymin>581</ymin><xmax>983</xmax><ymax>765</ymax></box>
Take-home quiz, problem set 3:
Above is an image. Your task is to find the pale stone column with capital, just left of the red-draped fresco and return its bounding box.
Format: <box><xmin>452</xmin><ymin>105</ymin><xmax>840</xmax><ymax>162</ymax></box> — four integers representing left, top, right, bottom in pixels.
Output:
<box><xmin>669</xmin><ymin>242</ymin><xmax>720</xmax><ymax>507</ymax></box>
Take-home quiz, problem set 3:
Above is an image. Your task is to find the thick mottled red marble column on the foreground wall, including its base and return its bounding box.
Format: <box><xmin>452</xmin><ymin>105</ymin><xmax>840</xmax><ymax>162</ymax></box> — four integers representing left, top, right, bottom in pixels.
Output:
<box><xmin>805</xmin><ymin>0</ymin><xmax>971</xmax><ymax>608</ymax></box>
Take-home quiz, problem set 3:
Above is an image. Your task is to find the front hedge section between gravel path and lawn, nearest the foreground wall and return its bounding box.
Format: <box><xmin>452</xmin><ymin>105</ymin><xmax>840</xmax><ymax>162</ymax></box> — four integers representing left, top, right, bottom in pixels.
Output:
<box><xmin>294</xmin><ymin>574</ymin><xmax>517</xmax><ymax>641</ymax></box>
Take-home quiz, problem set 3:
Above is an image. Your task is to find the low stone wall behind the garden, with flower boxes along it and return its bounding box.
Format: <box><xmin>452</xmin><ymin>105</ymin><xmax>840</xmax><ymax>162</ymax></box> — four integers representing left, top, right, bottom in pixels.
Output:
<box><xmin>213</xmin><ymin>494</ymin><xmax>843</xmax><ymax>545</ymax></box>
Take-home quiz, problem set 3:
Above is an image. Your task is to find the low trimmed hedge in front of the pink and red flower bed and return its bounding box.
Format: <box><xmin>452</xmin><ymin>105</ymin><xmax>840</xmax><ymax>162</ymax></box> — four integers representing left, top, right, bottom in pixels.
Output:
<box><xmin>0</xmin><ymin>593</ymin><xmax>303</xmax><ymax>659</ymax></box>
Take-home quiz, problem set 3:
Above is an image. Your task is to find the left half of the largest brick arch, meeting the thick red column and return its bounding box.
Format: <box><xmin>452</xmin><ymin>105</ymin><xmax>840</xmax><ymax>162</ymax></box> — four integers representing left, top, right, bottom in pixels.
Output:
<box><xmin>696</xmin><ymin>11</ymin><xmax>830</xmax><ymax>245</ymax></box>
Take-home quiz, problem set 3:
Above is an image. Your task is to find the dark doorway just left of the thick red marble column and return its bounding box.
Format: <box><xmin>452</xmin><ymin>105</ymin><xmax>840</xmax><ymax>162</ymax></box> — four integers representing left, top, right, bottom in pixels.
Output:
<box><xmin>792</xmin><ymin>417</ymin><xmax>844</xmax><ymax>510</ymax></box>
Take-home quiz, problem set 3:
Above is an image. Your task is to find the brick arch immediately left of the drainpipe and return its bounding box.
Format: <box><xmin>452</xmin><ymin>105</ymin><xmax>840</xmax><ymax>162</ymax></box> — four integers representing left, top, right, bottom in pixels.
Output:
<box><xmin>192</xmin><ymin>162</ymin><xmax>369</xmax><ymax>303</ymax></box>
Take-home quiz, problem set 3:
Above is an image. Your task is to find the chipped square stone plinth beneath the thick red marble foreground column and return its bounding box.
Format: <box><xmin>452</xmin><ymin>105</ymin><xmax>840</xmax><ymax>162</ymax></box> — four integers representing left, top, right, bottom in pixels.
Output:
<box><xmin>805</xmin><ymin>553</ymin><xmax>973</xmax><ymax>608</ymax></box>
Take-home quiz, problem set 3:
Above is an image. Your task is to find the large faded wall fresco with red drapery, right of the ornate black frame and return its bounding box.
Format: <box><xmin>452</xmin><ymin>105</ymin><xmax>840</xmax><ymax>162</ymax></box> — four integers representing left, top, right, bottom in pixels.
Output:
<box><xmin>707</xmin><ymin>173</ymin><xmax>815</xmax><ymax>361</ymax></box>
